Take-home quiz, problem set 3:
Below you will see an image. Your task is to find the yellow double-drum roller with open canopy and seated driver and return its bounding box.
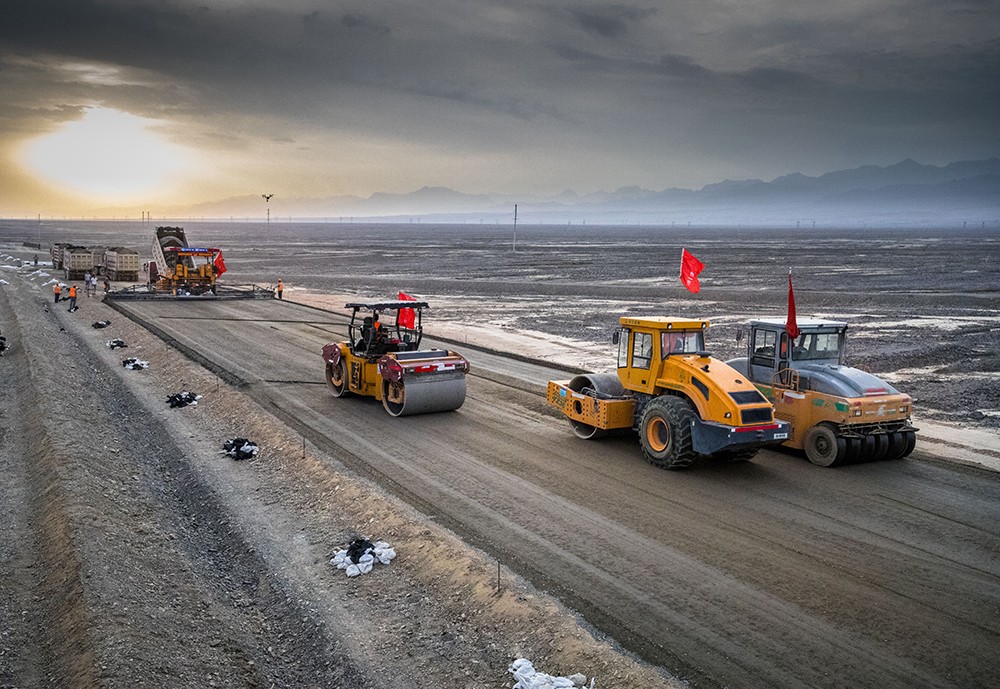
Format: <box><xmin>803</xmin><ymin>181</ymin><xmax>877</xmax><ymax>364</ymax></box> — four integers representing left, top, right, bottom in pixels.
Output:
<box><xmin>323</xmin><ymin>301</ymin><xmax>469</xmax><ymax>416</ymax></box>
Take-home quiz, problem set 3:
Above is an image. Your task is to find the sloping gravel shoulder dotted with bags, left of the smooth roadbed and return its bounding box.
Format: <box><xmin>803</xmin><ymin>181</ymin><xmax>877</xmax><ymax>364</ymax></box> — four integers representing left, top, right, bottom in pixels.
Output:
<box><xmin>0</xmin><ymin>266</ymin><xmax>679</xmax><ymax>688</ymax></box>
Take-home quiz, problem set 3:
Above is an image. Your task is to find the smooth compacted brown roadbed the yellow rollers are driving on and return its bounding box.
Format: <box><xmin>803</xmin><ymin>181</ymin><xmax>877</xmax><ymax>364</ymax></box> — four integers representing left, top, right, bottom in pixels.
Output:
<box><xmin>97</xmin><ymin>301</ymin><xmax>1000</xmax><ymax>687</ymax></box>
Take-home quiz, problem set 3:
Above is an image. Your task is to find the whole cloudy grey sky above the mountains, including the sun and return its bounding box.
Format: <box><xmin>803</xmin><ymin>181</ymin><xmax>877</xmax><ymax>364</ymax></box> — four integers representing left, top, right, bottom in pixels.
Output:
<box><xmin>0</xmin><ymin>0</ymin><xmax>1000</xmax><ymax>214</ymax></box>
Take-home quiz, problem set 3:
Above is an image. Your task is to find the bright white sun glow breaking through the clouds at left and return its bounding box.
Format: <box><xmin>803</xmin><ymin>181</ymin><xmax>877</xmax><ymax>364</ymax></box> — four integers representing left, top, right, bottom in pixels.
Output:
<box><xmin>23</xmin><ymin>108</ymin><xmax>190</xmax><ymax>203</ymax></box>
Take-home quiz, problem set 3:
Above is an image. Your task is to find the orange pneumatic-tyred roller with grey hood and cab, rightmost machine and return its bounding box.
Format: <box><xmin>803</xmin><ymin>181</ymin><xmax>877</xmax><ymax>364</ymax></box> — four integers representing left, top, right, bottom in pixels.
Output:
<box><xmin>726</xmin><ymin>319</ymin><xmax>918</xmax><ymax>467</ymax></box>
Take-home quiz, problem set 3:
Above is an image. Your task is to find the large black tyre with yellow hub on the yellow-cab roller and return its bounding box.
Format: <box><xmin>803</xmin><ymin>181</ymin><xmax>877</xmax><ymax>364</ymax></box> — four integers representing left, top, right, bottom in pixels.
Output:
<box><xmin>639</xmin><ymin>395</ymin><xmax>698</xmax><ymax>469</ymax></box>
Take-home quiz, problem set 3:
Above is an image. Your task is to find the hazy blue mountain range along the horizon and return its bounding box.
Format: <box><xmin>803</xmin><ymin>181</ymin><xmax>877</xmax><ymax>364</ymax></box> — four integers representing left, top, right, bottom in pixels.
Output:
<box><xmin>170</xmin><ymin>158</ymin><xmax>1000</xmax><ymax>226</ymax></box>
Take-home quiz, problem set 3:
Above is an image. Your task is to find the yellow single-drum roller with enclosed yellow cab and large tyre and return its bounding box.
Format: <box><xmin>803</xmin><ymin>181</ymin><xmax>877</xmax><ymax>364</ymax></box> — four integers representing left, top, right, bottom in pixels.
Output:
<box><xmin>548</xmin><ymin>316</ymin><xmax>789</xmax><ymax>469</ymax></box>
